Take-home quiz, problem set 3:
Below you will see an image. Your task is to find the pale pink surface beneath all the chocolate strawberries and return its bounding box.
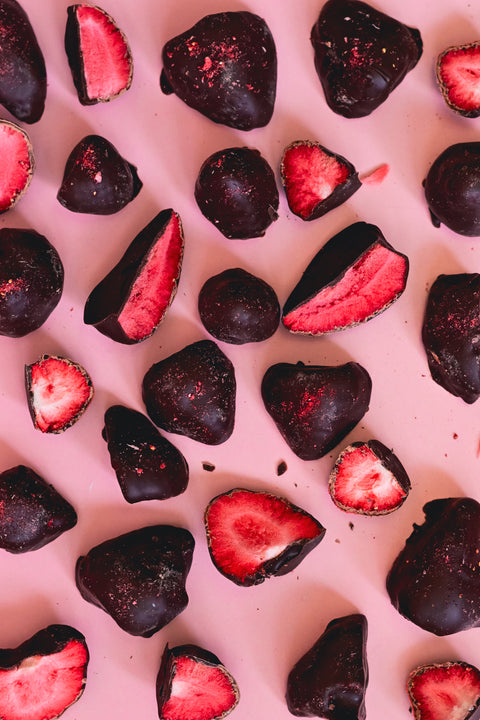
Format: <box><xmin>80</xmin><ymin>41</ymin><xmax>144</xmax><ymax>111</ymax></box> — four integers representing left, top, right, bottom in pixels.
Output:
<box><xmin>0</xmin><ymin>0</ymin><xmax>480</xmax><ymax>720</ymax></box>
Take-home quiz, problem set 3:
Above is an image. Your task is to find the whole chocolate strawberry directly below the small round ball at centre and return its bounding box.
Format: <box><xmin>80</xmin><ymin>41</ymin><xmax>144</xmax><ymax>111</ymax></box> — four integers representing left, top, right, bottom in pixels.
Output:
<box><xmin>142</xmin><ymin>340</ymin><xmax>236</xmax><ymax>445</ymax></box>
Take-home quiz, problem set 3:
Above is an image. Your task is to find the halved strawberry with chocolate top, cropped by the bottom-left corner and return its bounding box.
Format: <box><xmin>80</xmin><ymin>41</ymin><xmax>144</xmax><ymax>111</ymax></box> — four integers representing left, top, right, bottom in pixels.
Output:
<box><xmin>0</xmin><ymin>625</ymin><xmax>89</xmax><ymax>720</ymax></box>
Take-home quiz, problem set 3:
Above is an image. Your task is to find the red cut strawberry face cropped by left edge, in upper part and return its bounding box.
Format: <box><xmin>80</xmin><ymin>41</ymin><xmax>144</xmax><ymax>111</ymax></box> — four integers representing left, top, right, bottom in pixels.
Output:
<box><xmin>0</xmin><ymin>122</ymin><xmax>33</xmax><ymax>212</ymax></box>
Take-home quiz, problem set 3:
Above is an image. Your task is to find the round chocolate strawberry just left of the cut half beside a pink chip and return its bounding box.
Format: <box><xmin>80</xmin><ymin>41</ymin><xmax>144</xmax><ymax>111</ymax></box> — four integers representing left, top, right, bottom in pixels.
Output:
<box><xmin>195</xmin><ymin>147</ymin><xmax>279</xmax><ymax>240</ymax></box>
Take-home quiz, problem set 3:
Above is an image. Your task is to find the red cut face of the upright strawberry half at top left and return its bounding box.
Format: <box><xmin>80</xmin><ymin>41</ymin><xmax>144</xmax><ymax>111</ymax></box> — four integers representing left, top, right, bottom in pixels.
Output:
<box><xmin>77</xmin><ymin>5</ymin><xmax>132</xmax><ymax>100</ymax></box>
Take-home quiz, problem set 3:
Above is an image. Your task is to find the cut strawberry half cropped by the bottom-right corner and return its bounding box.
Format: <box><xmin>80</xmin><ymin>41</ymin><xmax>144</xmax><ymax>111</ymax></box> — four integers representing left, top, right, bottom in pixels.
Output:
<box><xmin>407</xmin><ymin>661</ymin><xmax>480</xmax><ymax>720</ymax></box>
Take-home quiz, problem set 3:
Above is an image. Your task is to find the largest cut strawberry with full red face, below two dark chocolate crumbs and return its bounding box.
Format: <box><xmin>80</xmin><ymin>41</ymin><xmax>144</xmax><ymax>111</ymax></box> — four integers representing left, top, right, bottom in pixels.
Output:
<box><xmin>205</xmin><ymin>488</ymin><xmax>325</xmax><ymax>587</ymax></box>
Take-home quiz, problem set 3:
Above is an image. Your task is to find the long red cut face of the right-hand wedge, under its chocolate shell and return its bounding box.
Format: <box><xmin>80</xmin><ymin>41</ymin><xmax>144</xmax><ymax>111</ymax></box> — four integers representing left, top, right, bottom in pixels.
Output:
<box><xmin>283</xmin><ymin>243</ymin><xmax>407</xmax><ymax>335</ymax></box>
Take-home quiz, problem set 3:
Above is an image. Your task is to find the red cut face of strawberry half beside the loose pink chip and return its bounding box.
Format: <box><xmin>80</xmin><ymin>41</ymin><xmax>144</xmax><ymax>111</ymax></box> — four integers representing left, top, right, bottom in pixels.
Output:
<box><xmin>283</xmin><ymin>144</ymin><xmax>349</xmax><ymax>218</ymax></box>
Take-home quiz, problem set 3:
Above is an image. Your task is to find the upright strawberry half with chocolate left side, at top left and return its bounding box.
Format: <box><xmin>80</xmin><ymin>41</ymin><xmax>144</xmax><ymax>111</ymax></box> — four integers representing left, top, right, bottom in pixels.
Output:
<box><xmin>65</xmin><ymin>3</ymin><xmax>133</xmax><ymax>105</ymax></box>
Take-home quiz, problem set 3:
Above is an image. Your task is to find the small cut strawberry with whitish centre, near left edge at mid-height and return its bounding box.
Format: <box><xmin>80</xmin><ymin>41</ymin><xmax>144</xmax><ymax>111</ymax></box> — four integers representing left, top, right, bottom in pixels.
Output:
<box><xmin>25</xmin><ymin>355</ymin><xmax>93</xmax><ymax>433</ymax></box>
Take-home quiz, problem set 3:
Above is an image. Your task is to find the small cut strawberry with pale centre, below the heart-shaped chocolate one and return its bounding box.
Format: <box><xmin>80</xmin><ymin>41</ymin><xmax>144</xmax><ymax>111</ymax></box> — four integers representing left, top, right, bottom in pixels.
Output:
<box><xmin>328</xmin><ymin>440</ymin><xmax>411</xmax><ymax>515</ymax></box>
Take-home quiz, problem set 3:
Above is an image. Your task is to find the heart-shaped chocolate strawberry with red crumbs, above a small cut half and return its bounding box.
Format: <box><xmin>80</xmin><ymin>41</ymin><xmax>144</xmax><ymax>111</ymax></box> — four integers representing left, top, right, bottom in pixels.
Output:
<box><xmin>262</xmin><ymin>362</ymin><xmax>372</xmax><ymax>460</ymax></box>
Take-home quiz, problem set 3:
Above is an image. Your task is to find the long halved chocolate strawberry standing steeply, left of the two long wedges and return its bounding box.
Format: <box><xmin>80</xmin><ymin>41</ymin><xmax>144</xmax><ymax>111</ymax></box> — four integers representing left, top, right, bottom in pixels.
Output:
<box><xmin>84</xmin><ymin>209</ymin><xmax>184</xmax><ymax>345</ymax></box>
